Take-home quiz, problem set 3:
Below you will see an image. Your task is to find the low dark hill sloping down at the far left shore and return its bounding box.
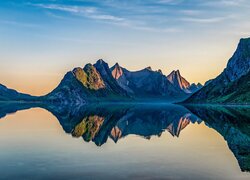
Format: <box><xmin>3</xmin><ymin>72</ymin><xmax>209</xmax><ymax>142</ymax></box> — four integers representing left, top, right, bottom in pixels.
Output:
<box><xmin>0</xmin><ymin>84</ymin><xmax>37</xmax><ymax>101</ymax></box>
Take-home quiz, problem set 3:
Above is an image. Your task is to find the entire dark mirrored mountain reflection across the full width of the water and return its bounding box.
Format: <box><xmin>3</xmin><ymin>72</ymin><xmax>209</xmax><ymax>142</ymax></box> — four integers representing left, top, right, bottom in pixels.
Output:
<box><xmin>0</xmin><ymin>103</ymin><xmax>250</xmax><ymax>171</ymax></box>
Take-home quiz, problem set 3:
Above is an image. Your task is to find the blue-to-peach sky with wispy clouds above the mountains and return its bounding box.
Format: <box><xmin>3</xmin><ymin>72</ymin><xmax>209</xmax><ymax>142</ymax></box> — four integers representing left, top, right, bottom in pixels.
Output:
<box><xmin>0</xmin><ymin>0</ymin><xmax>250</xmax><ymax>95</ymax></box>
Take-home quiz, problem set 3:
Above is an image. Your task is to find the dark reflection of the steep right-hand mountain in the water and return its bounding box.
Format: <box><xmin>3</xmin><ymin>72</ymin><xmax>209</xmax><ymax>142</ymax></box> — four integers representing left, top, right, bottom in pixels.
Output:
<box><xmin>187</xmin><ymin>106</ymin><xmax>250</xmax><ymax>171</ymax></box>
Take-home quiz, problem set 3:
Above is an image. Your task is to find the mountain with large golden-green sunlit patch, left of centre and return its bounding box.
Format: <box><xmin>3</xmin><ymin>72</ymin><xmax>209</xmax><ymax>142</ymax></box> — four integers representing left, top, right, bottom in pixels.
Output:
<box><xmin>43</xmin><ymin>60</ymin><xmax>129</xmax><ymax>104</ymax></box>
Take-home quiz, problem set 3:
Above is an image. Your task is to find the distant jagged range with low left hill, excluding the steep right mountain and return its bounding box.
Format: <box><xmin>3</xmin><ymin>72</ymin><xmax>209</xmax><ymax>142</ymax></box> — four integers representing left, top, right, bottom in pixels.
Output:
<box><xmin>0</xmin><ymin>59</ymin><xmax>202</xmax><ymax>104</ymax></box>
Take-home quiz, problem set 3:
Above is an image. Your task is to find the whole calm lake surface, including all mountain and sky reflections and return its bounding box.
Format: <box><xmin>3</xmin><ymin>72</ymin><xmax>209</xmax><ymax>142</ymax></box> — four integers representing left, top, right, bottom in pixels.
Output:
<box><xmin>0</xmin><ymin>104</ymin><xmax>250</xmax><ymax>179</ymax></box>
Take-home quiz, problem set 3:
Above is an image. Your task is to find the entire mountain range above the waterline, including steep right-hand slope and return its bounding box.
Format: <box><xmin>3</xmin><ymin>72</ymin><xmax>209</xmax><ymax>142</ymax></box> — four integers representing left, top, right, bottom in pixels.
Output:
<box><xmin>0</xmin><ymin>38</ymin><xmax>250</xmax><ymax>104</ymax></box>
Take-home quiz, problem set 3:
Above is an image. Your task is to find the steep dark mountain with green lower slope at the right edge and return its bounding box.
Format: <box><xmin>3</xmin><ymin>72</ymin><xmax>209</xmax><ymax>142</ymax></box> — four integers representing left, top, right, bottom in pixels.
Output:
<box><xmin>184</xmin><ymin>38</ymin><xmax>250</xmax><ymax>104</ymax></box>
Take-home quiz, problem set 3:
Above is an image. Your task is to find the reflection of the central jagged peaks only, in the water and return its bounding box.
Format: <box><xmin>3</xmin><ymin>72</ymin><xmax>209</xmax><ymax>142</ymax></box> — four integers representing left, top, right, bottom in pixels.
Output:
<box><xmin>44</xmin><ymin>105</ymin><xmax>201</xmax><ymax>146</ymax></box>
